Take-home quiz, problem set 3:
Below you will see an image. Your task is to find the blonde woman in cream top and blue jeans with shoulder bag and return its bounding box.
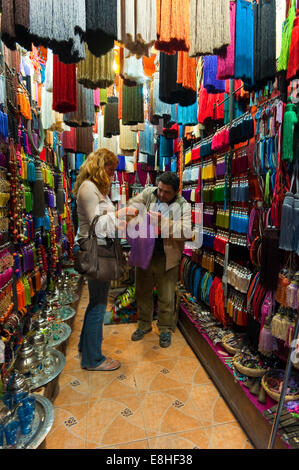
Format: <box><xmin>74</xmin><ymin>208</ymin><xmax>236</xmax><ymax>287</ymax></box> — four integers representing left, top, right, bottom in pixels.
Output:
<box><xmin>73</xmin><ymin>149</ymin><xmax>136</xmax><ymax>371</ymax></box>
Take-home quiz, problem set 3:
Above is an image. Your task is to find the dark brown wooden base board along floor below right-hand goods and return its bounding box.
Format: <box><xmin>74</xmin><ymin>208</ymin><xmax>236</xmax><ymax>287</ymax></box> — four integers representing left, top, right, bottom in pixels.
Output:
<box><xmin>178</xmin><ymin>304</ymin><xmax>290</xmax><ymax>449</ymax></box>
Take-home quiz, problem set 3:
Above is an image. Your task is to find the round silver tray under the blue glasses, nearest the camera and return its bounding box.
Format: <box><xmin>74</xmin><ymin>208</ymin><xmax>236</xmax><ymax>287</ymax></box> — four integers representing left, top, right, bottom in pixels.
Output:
<box><xmin>3</xmin><ymin>394</ymin><xmax>54</xmax><ymax>449</ymax></box>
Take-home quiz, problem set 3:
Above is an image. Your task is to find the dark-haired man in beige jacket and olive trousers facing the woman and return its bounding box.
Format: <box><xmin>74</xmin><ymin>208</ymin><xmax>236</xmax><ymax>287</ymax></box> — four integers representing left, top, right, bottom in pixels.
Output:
<box><xmin>129</xmin><ymin>172</ymin><xmax>192</xmax><ymax>348</ymax></box>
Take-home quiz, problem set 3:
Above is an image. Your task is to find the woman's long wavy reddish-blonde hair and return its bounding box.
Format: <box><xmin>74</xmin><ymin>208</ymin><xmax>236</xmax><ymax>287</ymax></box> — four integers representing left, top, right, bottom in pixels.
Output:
<box><xmin>73</xmin><ymin>149</ymin><xmax>118</xmax><ymax>197</ymax></box>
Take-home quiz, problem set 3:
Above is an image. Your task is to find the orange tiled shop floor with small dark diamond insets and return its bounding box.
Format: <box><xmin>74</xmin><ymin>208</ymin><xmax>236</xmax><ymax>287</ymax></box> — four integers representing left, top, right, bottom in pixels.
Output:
<box><xmin>46</xmin><ymin>286</ymin><xmax>252</xmax><ymax>449</ymax></box>
